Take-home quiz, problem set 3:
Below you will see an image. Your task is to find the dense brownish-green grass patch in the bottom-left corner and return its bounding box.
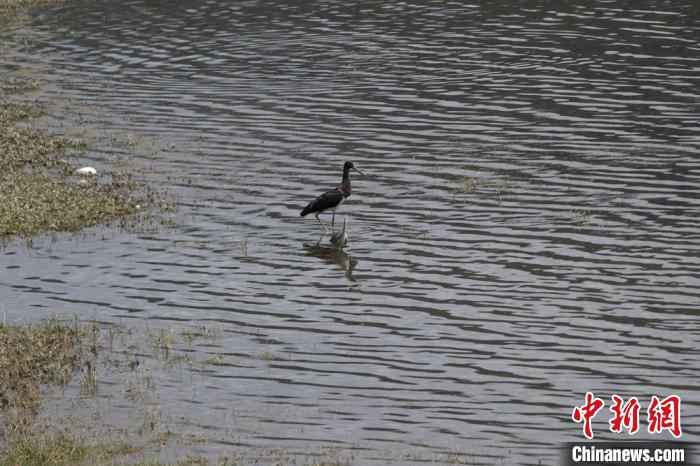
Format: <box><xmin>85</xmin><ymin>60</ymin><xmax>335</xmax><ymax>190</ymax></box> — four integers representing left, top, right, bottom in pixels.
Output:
<box><xmin>0</xmin><ymin>317</ymin><xmax>136</xmax><ymax>466</ymax></box>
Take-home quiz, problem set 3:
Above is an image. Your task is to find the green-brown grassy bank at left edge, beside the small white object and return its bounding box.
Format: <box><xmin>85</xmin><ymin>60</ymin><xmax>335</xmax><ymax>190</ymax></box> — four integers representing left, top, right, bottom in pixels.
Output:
<box><xmin>0</xmin><ymin>80</ymin><xmax>172</xmax><ymax>240</ymax></box>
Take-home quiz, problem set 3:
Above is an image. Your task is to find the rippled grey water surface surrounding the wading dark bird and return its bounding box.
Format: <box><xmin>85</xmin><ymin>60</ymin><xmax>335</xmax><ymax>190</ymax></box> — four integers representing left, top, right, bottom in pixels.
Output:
<box><xmin>0</xmin><ymin>0</ymin><xmax>700</xmax><ymax>464</ymax></box>
